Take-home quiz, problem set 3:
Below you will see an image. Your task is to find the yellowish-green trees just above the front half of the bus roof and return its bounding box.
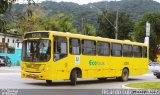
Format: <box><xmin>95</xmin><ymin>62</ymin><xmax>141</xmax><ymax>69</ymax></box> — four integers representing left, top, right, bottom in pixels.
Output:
<box><xmin>16</xmin><ymin>13</ymin><xmax>77</xmax><ymax>34</ymax></box>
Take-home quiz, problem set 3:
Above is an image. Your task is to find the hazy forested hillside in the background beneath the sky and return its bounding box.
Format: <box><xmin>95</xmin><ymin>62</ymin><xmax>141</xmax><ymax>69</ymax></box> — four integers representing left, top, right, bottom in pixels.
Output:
<box><xmin>3</xmin><ymin>0</ymin><xmax>160</xmax><ymax>31</ymax></box>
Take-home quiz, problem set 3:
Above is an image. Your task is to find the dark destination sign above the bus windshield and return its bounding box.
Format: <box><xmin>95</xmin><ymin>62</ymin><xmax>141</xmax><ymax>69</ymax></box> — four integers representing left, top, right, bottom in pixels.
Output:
<box><xmin>24</xmin><ymin>32</ymin><xmax>49</xmax><ymax>39</ymax></box>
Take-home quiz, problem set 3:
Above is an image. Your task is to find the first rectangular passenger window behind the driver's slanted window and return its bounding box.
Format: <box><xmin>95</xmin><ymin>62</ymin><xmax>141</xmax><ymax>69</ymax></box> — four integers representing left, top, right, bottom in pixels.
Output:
<box><xmin>69</xmin><ymin>38</ymin><xmax>81</xmax><ymax>54</ymax></box>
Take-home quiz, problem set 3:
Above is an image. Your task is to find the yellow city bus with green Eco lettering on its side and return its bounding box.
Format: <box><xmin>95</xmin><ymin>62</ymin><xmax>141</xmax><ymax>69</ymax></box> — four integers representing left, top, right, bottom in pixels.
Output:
<box><xmin>21</xmin><ymin>31</ymin><xmax>149</xmax><ymax>85</ymax></box>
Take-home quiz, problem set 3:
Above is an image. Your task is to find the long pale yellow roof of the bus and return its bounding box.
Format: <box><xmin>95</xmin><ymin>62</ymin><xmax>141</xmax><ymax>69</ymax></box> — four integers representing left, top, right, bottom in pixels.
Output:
<box><xmin>25</xmin><ymin>31</ymin><xmax>148</xmax><ymax>46</ymax></box>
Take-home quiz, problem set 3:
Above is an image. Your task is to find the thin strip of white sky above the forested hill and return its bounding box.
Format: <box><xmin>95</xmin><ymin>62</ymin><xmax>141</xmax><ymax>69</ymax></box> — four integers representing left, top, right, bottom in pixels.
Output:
<box><xmin>17</xmin><ymin>0</ymin><xmax>160</xmax><ymax>4</ymax></box>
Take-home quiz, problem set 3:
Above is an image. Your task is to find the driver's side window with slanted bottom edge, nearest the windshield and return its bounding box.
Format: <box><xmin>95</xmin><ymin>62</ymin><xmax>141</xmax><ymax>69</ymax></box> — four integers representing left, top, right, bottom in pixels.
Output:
<box><xmin>54</xmin><ymin>36</ymin><xmax>68</xmax><ymax>61</ymax></box>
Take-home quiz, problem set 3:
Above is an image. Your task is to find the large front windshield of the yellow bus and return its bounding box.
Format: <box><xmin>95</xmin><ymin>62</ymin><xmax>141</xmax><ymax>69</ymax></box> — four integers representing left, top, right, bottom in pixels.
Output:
<box><xmin>22</xmin><ymin>40</ymin><xmax>51</xmax><ymax>62</ymax></box>
